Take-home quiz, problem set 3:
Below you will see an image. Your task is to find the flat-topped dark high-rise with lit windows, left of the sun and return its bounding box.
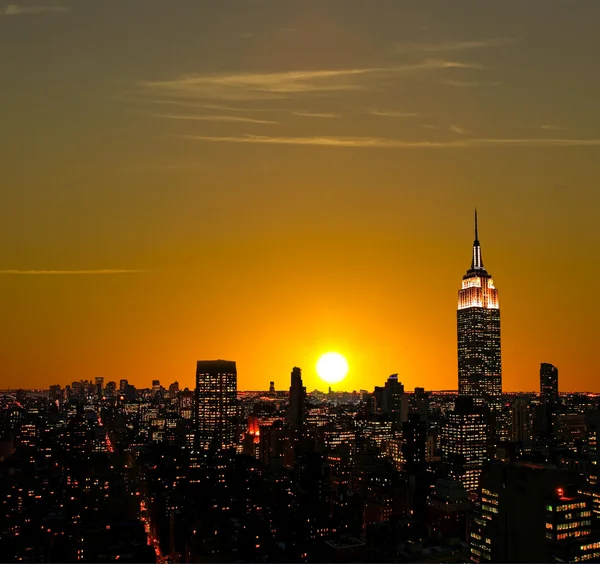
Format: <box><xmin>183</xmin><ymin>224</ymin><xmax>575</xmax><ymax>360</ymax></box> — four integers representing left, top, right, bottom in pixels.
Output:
<box><xmin>196</xmin><ymin>360</ymin><xmax>237</xmax><ymax>451</ymax></box>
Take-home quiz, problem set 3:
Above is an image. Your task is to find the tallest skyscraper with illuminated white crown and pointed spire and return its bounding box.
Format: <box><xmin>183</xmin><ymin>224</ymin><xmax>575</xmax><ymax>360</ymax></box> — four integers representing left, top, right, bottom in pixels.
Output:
<box><xmin>457</xmin><ymin>210</ymin><xmax>502</xmax><ymax>408</ymax></box>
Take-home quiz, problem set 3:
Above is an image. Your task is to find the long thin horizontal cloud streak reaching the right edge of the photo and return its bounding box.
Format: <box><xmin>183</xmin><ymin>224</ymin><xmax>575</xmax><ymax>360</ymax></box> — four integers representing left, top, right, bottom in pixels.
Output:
<box><xmin>183</xmin><ymin>135</ymin><xmax>600</xmax><ymax>149</ymax></box>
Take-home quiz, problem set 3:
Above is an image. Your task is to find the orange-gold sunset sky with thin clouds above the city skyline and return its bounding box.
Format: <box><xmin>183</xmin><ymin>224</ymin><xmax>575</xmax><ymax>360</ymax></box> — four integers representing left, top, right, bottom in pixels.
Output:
<box><xmin>0</xmin><ymin>0</ymin><xmax>600</xmax><ymax>392</ymax></box>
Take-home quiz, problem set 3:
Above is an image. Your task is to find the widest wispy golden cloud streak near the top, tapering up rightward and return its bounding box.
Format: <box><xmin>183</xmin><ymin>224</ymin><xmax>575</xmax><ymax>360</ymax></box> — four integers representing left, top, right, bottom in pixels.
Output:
<box><xmin>139</xmin><ymin>59</ymin><xmax>483</xmax><ymax>101</ymax></box>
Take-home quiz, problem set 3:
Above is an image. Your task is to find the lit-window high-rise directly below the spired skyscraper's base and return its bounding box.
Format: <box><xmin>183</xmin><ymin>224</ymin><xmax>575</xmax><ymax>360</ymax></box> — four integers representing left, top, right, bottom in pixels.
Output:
<box><xmin>440</xmin><ymin>396</ymin><xmax>488</xmax><ymax>495</ymax></box>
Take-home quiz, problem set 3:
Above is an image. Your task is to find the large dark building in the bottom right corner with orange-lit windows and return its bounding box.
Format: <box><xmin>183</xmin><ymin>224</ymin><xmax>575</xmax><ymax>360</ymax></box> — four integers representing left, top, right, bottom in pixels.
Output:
<box><xmin>469</xmin><ymin>462</ymin><xmax>600</xmax><ymax>562</ymax></box>
